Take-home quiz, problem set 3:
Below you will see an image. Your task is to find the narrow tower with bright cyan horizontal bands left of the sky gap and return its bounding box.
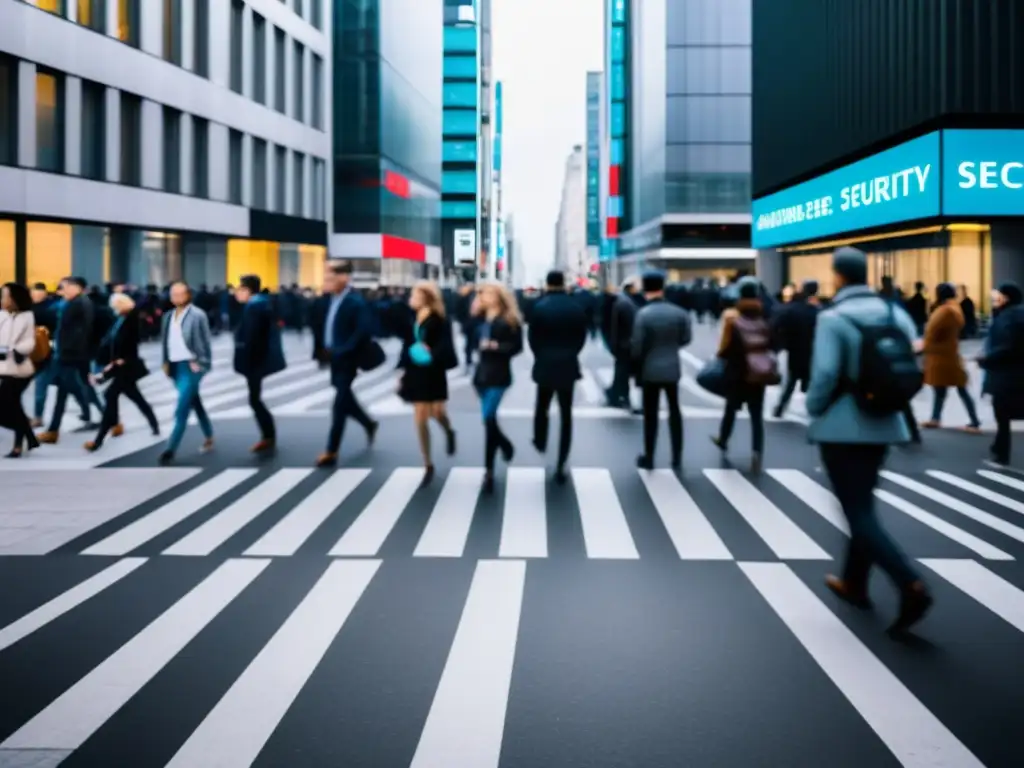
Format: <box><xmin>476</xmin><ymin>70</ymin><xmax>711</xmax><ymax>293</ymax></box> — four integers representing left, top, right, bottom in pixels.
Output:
<box><xmin>441</xmin><ymin>0</ymin><xmax>493</xmax><ymax>278</ymax></box>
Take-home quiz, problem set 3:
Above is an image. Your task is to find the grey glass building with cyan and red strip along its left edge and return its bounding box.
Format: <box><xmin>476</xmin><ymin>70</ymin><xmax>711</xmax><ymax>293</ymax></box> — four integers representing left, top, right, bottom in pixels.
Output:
<box><xmin>606</xmin><ymin>0</ymin><xmax>754</xmax><ymax>281</ymax></box>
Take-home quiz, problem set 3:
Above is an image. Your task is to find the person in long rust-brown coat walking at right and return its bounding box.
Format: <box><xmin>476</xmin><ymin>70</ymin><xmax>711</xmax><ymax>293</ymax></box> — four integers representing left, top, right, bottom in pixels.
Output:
<box><xmin>921</xmin><ymin>283</ymin><xmax>981</xmax><ymax>434</ymax></box>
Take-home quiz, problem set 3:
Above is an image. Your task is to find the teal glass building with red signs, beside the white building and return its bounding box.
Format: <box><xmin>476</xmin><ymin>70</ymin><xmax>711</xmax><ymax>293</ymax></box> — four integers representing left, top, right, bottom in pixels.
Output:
<box><xmin>329</xmin><ymin>0</ymin><xmax>443</xmax><ymax>286</ymax></box>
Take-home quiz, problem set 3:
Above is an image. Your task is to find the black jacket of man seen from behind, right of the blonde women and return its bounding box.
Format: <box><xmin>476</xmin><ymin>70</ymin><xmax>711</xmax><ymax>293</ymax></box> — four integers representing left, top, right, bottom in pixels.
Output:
<box><xmin>527</xmin><ymin>293</ymin><xmax>590</xmax><ymax>389</ymax></box>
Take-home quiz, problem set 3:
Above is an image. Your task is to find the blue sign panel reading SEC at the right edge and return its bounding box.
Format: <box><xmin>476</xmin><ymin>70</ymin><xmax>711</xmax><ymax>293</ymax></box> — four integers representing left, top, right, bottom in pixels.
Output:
<box><xmin>942</xmin><ymin>130</ymin><xmax>1024</xmax><ymax>216</ymax></box>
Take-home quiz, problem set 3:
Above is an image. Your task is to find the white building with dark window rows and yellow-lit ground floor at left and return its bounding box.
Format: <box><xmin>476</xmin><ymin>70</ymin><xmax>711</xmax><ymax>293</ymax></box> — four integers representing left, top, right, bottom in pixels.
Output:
<box><xmin>0</xmin><ymin>0</ymin><xmax>331</xmax><ymax>288</ymax></box>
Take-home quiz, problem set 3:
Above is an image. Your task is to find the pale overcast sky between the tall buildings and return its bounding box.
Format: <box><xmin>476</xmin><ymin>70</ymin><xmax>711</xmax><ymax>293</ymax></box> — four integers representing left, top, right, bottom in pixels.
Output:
<box><xmin>490</xmin><ymin>0</ymin><xmax>605</xmax><ymax>282</ymax></box>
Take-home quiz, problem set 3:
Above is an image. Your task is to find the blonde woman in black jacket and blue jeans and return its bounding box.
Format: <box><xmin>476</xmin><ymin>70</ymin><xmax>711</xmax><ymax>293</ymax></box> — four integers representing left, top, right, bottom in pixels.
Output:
<box><xmin>473</xmin><ymin>283</ymin><xmax>522</xmax><ymax>494</ymax></box>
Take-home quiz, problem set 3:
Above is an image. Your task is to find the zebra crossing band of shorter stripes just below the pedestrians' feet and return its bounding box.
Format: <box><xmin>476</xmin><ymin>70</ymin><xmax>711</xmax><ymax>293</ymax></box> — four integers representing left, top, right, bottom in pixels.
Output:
<box><xmin>6</xmin><ymin>466</ymin><xmax>1024</xmax><ymax>561</ymax></box>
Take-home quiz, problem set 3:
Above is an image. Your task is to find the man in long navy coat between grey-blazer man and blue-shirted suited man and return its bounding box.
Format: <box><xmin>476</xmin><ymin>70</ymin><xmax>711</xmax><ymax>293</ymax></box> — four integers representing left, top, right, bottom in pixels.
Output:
<box><xmin>234</xmin><ymin>274</ymin><xmax>285</xmax><ymax>454</ymax></box>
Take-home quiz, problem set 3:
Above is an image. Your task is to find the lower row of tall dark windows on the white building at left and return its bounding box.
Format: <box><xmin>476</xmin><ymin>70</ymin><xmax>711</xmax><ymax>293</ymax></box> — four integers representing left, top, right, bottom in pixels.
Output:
<box><xmin>0</xmin><ymin>58</ymin><xmax>327</xmax><ymax>219</ymax></box>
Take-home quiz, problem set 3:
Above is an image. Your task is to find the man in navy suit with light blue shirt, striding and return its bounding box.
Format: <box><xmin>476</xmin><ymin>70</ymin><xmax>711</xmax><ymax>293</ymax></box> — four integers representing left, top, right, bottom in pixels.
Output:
<box><xmin>312</xmin><ymin>259</ymin><xmax>380</xmax><ymax>467</ymax></box>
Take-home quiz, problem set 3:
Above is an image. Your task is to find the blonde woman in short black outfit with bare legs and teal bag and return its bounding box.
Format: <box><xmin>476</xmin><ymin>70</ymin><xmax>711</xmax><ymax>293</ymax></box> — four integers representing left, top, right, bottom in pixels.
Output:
<box><xmin>398</xmin><ymin>281</ymin><xmax>458</xmax><ymax>485</ymax></box>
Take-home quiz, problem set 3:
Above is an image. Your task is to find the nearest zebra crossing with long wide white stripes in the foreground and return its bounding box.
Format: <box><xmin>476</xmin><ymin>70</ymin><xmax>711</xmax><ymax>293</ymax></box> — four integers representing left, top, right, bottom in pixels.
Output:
<box><xmin>0</xmin><ymin>556</ymin><xmax>1024</xmax><ymax>768</ymax></box>
